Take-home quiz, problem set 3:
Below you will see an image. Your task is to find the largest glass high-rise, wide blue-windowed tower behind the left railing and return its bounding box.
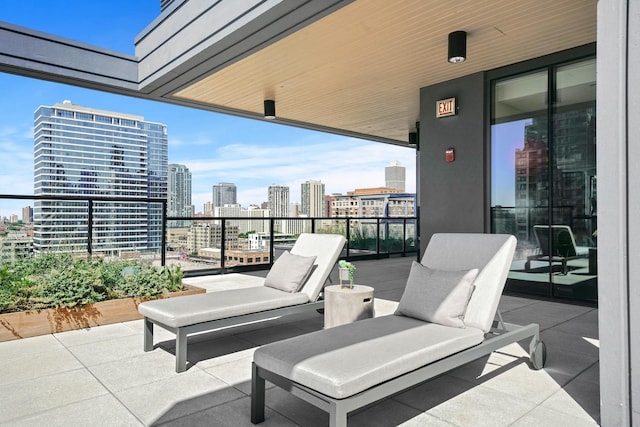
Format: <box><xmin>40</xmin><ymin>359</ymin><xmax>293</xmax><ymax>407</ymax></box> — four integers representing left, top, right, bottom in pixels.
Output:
<box><xmin>34</xmin><ymin>101</ymin><xmax>168</xmax><ymax>254</ymax></box>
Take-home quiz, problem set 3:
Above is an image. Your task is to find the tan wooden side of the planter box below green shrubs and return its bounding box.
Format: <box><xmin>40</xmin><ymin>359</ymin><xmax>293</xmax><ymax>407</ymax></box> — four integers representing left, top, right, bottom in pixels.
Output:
<box><xmin>0</xmin><ymin>285</ymin><xmax>206</xmax><ymax>342</ymax></box>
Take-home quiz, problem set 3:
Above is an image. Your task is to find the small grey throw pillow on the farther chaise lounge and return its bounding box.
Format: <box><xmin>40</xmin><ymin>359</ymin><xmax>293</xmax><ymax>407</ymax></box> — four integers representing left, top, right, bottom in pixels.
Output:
<box><xmin>264</xmin><ymin>251</ymin><xmax>316</xmax><ymax>292</ymax></box>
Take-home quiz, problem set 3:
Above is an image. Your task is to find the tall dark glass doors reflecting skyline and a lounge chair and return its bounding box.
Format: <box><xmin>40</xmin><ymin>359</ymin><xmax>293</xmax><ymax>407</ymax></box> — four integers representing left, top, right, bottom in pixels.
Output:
<box><xmin>491</xmin><ymin>59</ymin><xmax>597</xmax><ymax>300</ymax></box>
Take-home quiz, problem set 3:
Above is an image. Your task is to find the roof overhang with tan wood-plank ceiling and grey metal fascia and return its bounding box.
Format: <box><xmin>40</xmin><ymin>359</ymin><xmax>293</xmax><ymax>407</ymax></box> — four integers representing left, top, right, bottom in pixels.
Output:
<box><xmin>0</xmin><ymin>0</ymin><xmax>597</xmax><ymax>145</ymax></box>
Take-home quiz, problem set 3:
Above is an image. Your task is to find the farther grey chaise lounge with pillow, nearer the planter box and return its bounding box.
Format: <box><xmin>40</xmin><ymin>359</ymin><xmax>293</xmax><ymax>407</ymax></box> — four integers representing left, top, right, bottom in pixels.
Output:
<box><xmin>138</xmin><ymin>234</ymin><xmax>346</xmax><ymax>372</ymax></box>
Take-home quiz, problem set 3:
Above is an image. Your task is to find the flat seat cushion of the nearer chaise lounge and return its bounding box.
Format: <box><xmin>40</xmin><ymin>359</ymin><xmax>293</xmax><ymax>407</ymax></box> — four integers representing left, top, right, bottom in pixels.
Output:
<box><xmin>253</xmin><ymin>315</ymin><xmax>484</xmax><ymax>399</ymax></box>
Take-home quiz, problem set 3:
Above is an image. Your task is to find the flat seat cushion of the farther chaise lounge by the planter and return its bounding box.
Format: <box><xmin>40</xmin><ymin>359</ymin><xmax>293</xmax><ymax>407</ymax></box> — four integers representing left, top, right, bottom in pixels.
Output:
<box><xmin>138</xmin><ymin>286</ymin><xmax>309</xmax><ymax>328</ymax></box>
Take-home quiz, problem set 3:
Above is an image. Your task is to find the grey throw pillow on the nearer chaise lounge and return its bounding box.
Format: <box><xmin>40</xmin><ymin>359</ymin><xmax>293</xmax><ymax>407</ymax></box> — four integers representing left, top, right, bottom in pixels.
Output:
<box><xmin>396</xmin><ymin>261</ymin><xmax>478</xmax><ymax>328</ymax></box>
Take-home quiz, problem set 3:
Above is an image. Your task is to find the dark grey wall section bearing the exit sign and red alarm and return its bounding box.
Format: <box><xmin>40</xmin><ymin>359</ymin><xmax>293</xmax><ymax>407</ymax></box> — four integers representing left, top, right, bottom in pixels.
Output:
<box><xmin>418</xmin><ymin>73</ymin><xmax>487</xmax><ymax>253</ymax></box>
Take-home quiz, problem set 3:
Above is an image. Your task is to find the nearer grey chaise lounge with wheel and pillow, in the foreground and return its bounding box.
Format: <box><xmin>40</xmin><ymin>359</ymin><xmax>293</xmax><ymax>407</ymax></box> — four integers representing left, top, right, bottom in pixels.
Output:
<box><xmin>251</xmin><ymin>234</ymin><xmax>546</xmax><ymax>427</ymax></box>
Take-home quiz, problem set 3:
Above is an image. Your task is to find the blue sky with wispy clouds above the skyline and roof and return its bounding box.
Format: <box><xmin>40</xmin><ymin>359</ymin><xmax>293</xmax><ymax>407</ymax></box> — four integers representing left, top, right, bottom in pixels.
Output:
<box><xmin>0</xmin><ymin>0</ymin><xmax>415</xmax><ymax>216</ymax></box>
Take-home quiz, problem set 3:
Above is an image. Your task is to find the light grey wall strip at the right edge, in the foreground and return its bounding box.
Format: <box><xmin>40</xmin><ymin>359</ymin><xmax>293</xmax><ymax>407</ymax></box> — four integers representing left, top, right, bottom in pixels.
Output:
<box><xmin>597</xmin><ymin>0</ymin><xmax>640</xmax><ymax>426</ymax></box>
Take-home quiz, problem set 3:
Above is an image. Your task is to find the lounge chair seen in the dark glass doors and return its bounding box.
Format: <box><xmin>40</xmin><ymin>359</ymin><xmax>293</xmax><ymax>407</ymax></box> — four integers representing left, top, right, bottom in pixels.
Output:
<box><xmin>524</xmin><ymin>225</ymin><xmax>589</xmax><ymax>274</ymax></box>
